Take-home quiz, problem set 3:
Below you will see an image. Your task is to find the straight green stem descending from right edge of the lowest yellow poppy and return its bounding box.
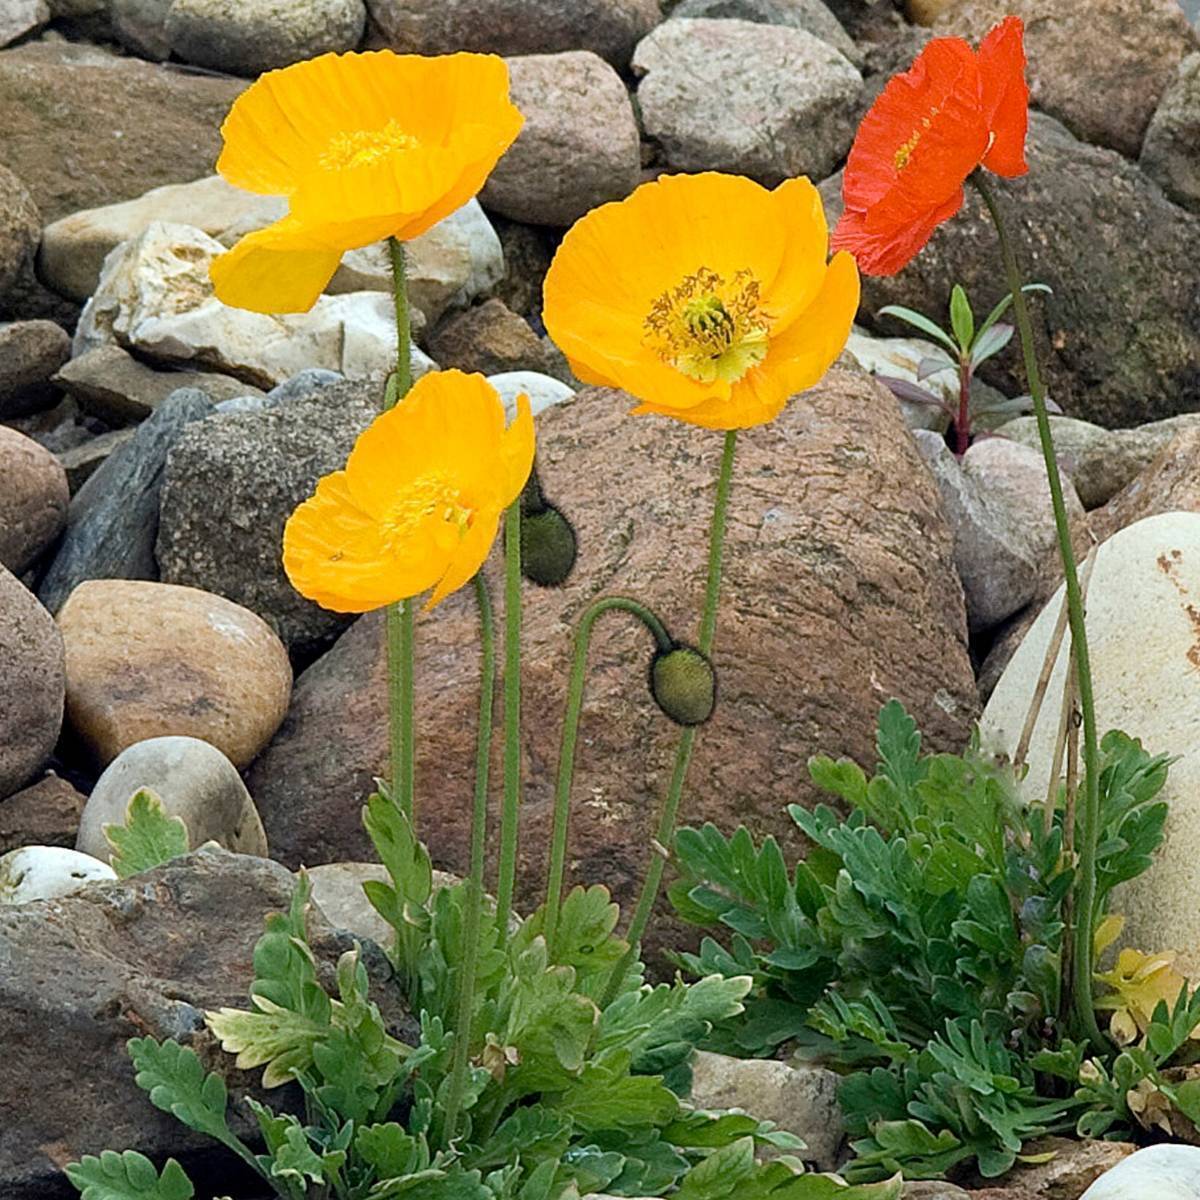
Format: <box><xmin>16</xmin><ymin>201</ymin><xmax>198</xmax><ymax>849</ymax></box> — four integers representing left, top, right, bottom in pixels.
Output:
<box><xmin>496</xmin><ymin>497</ymin><xmax>521</xmax><ymax>943</ymax></box>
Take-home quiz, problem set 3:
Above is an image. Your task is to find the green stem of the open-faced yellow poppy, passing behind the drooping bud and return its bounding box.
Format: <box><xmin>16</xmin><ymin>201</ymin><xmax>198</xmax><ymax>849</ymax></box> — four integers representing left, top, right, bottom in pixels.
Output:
<box><xmin>600</xmin><ymin>430</ymin><xmax>738</xmax><ymax>1008</ymax></box>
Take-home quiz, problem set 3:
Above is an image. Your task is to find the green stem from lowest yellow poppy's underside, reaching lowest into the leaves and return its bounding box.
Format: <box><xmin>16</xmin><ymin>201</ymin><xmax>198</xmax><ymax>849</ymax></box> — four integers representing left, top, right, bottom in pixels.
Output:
<box><xmin>445</xmin><ymin>575</ymin><xmax>496</xmax><ymax>1146</ymax></box>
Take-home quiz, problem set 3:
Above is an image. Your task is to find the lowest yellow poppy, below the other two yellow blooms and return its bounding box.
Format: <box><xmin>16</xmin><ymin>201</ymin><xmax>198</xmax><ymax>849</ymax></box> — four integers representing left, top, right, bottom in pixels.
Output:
<box><xmin>283</xmin><ymin>371</ymin><xmax>534</xmax><ymax>612</ymax></box>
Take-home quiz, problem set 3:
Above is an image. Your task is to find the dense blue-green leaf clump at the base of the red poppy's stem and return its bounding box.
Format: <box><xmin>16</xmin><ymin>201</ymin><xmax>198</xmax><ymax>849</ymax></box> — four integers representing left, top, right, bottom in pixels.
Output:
<box><xmin>672</xmin><ymin>701</ymin><xmax>1171</xmax><ymax>1178</ymax></box>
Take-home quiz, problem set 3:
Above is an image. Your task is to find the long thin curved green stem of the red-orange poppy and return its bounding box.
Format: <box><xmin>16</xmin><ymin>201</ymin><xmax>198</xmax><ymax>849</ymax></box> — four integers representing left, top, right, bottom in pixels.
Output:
<box><xmin>971</xmin><ymin>172</ymin><xmax>1106</xmax><ymax>1048</ymax></box>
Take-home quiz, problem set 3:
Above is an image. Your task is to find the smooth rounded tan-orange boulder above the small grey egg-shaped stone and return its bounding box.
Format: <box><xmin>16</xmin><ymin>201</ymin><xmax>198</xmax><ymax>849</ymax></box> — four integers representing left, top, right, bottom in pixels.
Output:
<box><xmin>58</xmin><ymin>580</ymin><xmax>292</xmax><ymax>768</ymax></box>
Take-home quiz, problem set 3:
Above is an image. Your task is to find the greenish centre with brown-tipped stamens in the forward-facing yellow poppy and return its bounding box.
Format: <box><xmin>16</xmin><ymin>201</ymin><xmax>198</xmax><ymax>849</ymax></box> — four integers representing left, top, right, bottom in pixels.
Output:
<box><xmin>643</xmin><ymin>266</ymin><xmax>767</xmax><ymax>383</ymax></box>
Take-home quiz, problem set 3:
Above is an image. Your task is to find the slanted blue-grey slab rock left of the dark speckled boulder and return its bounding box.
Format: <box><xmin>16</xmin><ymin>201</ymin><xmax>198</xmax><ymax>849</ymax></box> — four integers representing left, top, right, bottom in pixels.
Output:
<box><xmin>38</xmin><ymin>389</ymin><xmax>212</xmax><ymax>612</ymax></box>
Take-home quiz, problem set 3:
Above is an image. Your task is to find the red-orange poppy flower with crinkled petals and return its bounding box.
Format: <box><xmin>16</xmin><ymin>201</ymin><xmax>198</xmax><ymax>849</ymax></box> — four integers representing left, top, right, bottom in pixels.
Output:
<box><xmin>833</xmin><ymin>17</ymin><xmax>1030</xmax><ymax>275</ymax></box>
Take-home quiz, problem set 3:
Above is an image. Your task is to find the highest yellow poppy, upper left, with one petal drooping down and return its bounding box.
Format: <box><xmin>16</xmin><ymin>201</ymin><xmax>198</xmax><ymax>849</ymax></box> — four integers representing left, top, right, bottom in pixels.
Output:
<box><xmin>211</xmin><ymin>50</ymin><xmax>523</xmax><ymax>312</ymax></box>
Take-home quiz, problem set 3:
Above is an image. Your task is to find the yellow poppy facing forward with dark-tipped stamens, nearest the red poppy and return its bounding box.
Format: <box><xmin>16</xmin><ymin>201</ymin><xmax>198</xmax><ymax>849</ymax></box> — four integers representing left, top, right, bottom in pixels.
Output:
<box><xmin>544</xmin><ymin>173</ymin><xmax>858</xmax><ymax>430</ymax></box>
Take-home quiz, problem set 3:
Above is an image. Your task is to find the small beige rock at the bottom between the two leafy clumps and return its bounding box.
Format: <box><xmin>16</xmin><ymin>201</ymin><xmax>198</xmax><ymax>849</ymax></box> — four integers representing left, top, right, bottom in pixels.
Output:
<box><xmin>691</xmin><ymin>1050</ymin><xmax>846</xmax><ymax>1171</ymax></box>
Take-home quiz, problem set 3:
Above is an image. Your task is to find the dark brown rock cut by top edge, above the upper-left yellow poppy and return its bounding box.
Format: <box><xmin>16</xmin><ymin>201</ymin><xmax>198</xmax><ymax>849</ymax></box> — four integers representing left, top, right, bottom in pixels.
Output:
<box><xmin>367</xmin><ymin>0</ymin><xmax>662</xmax><ymax>67</ymax></box>
